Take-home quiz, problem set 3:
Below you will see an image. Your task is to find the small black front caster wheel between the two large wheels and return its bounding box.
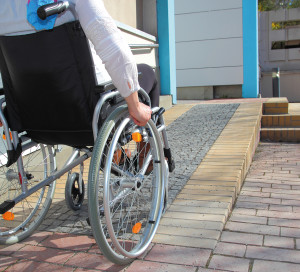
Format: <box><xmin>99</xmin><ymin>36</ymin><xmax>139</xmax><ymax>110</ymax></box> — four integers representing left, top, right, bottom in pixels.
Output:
<box><xmin>65</xmin><ymin>173</ymin><xmax>85</xmax><ymax>211</ymax></box>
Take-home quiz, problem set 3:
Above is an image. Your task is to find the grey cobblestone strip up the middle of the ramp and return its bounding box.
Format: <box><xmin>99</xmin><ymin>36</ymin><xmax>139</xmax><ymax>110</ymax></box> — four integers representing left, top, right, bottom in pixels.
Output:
<box><xmin>39</xmin><ymin>104</ymin><xmax>238</xmax><ymax>235</ymax></box>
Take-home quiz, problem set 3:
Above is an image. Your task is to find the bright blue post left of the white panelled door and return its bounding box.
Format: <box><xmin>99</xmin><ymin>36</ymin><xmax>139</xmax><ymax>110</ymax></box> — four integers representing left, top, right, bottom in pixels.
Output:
<box><xmin>156</xmin><ymin>0</ymin><xmax>177</xmax><ymax>104</ymax></box>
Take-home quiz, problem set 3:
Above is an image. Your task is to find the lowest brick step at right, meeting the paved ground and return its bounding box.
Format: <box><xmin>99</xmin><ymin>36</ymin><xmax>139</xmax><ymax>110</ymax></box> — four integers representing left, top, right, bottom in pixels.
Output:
<box><xmin>260</xmin><ymin>127</ymin><xmax>300</xmax><ymax>142</ymax></box>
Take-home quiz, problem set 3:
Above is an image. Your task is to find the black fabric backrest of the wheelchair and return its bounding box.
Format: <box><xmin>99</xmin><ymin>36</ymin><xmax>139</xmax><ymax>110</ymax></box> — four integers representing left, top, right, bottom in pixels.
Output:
<box><xmin>0</xmin><ymin>22</ymin><xmax>104</xmax><ymax>147</ymax></box>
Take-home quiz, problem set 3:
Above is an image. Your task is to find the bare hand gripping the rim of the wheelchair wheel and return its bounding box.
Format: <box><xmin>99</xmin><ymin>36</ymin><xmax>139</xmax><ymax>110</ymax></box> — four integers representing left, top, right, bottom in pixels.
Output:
<box><xmin>125</xmin><ymin>92</ymin><xmax>152</xmax><ymax>126</ymax></box>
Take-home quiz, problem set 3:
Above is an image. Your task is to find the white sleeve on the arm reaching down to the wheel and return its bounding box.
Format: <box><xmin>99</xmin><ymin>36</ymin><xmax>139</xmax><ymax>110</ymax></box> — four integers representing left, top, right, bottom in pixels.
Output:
<box><xmin>76</xmin><ymin>0</ymin><xmax>140</xmax><ymax>97</ymax></box>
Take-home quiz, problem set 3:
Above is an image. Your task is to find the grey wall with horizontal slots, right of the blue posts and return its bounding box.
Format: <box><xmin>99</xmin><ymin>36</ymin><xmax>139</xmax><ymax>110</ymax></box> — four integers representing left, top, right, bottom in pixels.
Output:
<box><xmin>259</xmin><ymin>8</ymin><xmax>300</xmax><ymax>102</ymax></box>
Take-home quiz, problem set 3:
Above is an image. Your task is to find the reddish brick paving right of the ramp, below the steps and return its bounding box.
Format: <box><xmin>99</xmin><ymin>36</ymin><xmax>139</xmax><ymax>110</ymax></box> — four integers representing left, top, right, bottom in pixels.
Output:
<box><xmin>208</xmin><ymin>143</ymin><xmax>300</xmax><ymax>272</ymax></box>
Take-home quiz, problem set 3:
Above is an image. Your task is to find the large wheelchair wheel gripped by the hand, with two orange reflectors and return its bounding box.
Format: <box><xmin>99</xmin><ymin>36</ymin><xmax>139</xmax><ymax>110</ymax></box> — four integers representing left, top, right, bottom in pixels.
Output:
<box><xmin>88</xmin><ymin>106</ymin><xmax>166</xmax><ymax>264</ymax></box>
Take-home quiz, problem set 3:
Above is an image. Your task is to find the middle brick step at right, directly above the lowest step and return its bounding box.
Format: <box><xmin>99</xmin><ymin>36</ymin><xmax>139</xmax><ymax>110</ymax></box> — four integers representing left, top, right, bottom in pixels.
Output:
<box><xmin>261</xmin><ymin>114</ymin><xmax>300</xmax><ymax>128</ymax></box>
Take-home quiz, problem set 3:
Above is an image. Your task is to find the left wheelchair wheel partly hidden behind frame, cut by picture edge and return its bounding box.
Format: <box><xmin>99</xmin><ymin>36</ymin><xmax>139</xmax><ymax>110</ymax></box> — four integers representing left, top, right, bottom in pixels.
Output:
<box><xmin>0</xmin><ymin>141</ymin><xmax>56</xmax><ymax>244</ymax></box>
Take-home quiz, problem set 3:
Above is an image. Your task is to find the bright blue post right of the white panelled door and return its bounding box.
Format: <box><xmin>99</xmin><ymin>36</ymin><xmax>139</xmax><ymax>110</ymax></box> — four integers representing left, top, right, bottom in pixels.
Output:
<box><xmin>243</xmin><ymin>0</ymin><xmax>259</xmax><ymax>98</ymax></box>
